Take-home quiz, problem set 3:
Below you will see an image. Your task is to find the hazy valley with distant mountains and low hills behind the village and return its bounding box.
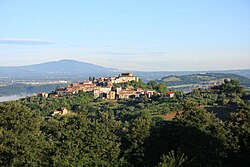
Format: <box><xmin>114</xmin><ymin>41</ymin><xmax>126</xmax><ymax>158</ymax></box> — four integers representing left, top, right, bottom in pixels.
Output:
<box><xmin>0</xmin><ymin>60</ymin><xmax>250</xmax><ymax>97</ymax></box>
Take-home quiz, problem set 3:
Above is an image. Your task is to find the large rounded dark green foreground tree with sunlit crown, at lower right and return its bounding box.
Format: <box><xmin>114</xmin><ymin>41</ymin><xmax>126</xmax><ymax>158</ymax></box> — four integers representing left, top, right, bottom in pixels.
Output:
<box><xmin>174</xmin><ymin>109</ymin><xmax>239</xmax><ymax>166</ymax></box>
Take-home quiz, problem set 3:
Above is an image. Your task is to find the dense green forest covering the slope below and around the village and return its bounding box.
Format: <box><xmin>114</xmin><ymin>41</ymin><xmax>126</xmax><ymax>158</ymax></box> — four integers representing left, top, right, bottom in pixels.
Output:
<box><xmin>0</xmin><ymin>79</ymin><xmax>250</xmax><ymax>167</ymax></box>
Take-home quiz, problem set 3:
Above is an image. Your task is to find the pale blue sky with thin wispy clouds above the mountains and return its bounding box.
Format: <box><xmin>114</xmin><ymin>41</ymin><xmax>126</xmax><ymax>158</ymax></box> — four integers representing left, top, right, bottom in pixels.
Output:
<box><xmin>0</xmin><ymin>0</ymin><xmax>250</xmax><ymax>71</ymax></box>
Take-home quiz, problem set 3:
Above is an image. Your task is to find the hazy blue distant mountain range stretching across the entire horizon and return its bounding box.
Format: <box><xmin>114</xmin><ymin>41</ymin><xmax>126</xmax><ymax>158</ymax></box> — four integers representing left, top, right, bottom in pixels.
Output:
<box><xmin>0</xmin><ymin>60</ymin><xmax>250</xmax><ymax>82</ymax></box>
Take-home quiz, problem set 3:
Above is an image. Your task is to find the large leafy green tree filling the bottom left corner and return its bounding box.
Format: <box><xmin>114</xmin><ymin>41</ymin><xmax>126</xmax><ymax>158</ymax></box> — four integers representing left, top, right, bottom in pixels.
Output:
<box><xmin>0</xmin><ymin>102</ymin><xmax>48</xmax><ymax>166</ymax></box>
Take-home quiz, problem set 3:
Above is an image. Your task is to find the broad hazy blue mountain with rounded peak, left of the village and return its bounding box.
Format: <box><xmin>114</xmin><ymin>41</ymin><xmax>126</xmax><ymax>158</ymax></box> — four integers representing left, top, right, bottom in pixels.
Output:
<box><xmin>0</xmin><ymin>60</ymin><xmax>117</xmax><ymax>79</ymax></box>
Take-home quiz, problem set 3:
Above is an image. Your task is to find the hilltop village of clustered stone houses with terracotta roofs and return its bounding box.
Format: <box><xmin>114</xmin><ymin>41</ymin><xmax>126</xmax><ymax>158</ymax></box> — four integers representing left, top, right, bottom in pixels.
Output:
<box><xmin>38</xmin><ymin>73</ymin><xmax>167</xmax><ymax>99</ymax></box>
